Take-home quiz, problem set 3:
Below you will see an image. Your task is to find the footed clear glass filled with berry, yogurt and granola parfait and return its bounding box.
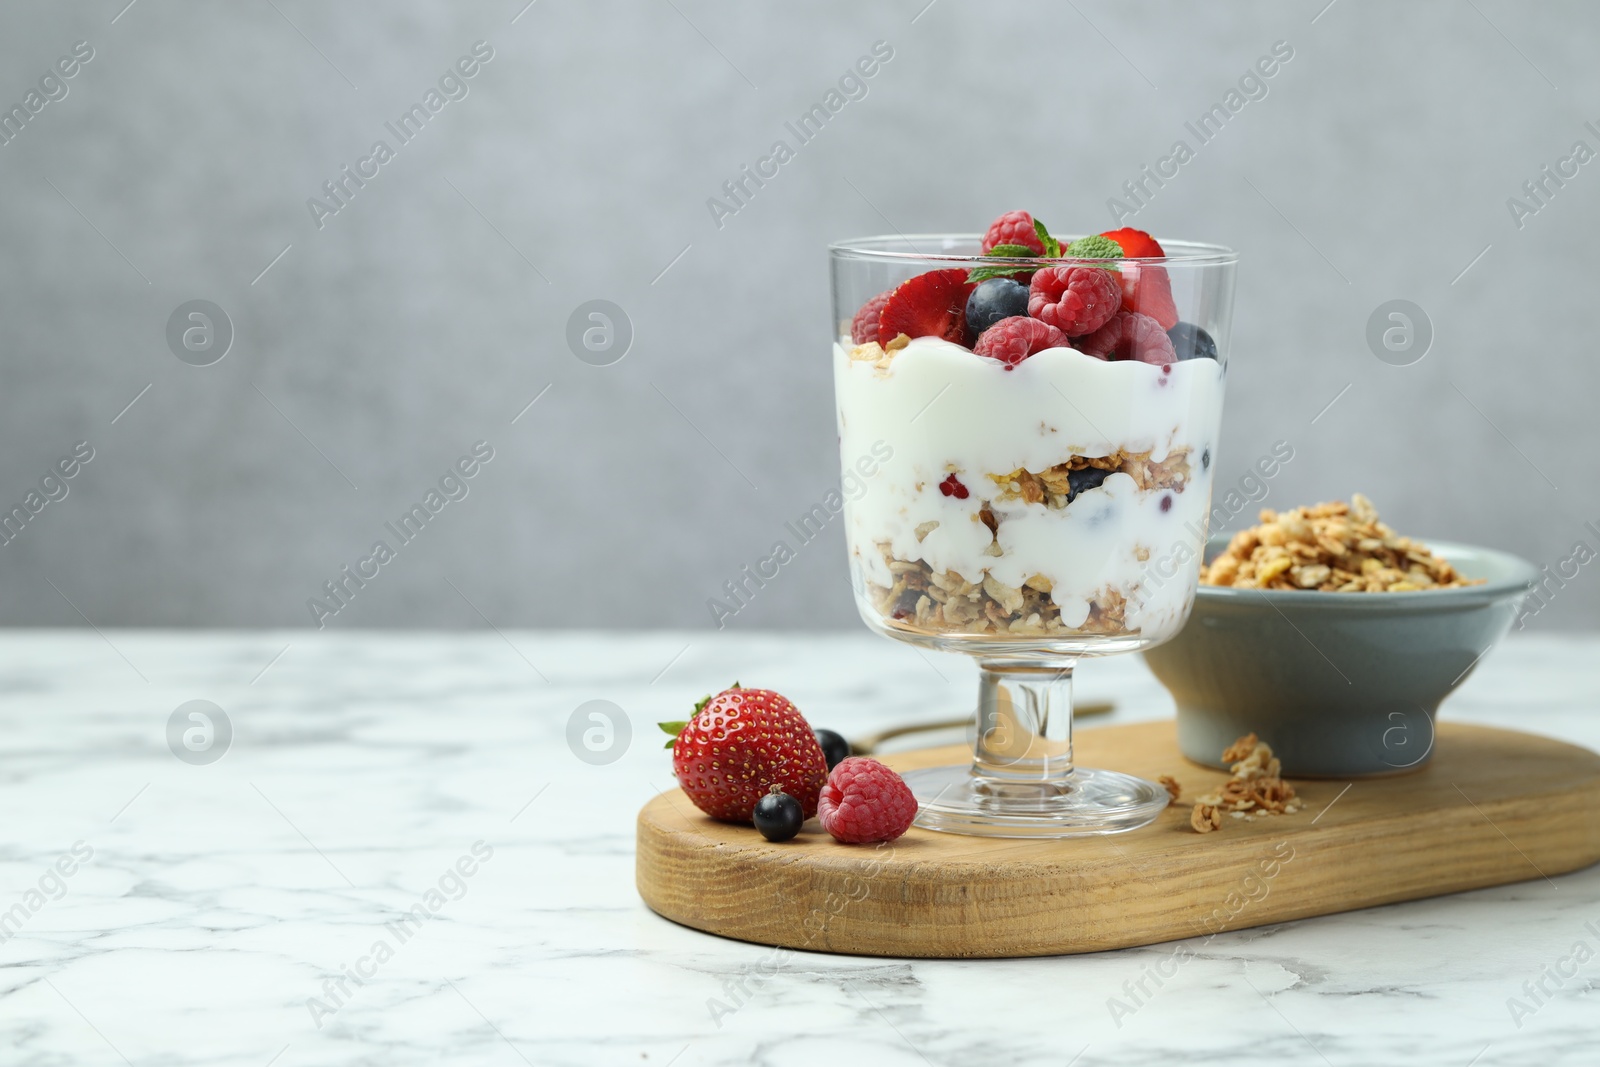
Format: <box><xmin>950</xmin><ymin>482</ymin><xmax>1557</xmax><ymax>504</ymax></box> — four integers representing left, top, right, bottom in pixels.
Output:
<box><xmin>830</xmin><ymin>211</ymin><xmax>1235</xmax><ymax>837</ymax></box>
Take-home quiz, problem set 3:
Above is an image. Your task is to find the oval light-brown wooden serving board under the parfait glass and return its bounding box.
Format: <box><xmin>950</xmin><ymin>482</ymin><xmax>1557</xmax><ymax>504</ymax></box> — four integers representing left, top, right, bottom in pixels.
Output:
<box><xmin>637</xmin><ymin>721</ymin><xmax>1600</xmax><ymax>958</ymax></box>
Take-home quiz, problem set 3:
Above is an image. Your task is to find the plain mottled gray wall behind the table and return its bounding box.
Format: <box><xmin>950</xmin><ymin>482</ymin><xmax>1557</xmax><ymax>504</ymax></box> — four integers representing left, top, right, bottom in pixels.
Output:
<box><xmin>0</xmin><ymin>0</ymin><xmax>1600</xmax><ymax>627</ymax></box>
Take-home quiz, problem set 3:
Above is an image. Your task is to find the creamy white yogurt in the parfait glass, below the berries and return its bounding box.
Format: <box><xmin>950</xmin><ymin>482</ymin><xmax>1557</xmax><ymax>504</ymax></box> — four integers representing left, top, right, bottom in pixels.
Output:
<box><xmin>834</xmin><ymin>338</ymin><xmax>1222</xmax><ymax>638</ymax></box>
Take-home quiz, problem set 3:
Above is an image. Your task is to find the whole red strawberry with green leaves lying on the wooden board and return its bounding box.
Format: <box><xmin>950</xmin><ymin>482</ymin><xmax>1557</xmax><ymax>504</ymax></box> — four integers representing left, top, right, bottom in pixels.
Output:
<box><xmin>661</xmin><ymin>683</ymin><xmax>827</xmax><ymax>822</ymax></box>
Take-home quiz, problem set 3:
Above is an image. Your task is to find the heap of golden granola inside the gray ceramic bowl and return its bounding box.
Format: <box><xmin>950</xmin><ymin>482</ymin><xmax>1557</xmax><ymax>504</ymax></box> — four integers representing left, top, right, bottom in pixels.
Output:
<box><xmin>1200</xmin><ymin>493</ymin><xmax>1483</xmax><ymax>593</ymax></box>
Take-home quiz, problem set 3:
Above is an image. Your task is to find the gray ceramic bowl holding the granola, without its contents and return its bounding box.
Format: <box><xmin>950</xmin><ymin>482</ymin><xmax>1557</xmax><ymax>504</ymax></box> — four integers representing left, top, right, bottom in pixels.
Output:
<box><xmin>1144</xmin><ymin>536</ymin><xmax>1538</xmax><ymax>777</ymax></box>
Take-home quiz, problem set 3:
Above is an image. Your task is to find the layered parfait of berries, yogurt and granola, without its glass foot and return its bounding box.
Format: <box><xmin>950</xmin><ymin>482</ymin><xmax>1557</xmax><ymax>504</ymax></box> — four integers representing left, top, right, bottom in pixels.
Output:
<box><xmin>834</xmin><ymin>211</ymin><xmax>1226</xmax><ymax>643</ymax></box>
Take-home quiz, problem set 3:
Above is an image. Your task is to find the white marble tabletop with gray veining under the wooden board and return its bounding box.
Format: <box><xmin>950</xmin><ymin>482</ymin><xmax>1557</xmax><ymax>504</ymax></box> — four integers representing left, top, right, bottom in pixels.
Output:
<box><xmin>0</xmin><ymin>630</ymin><xmax>1600</xmax><ymax>1067</ymax></box>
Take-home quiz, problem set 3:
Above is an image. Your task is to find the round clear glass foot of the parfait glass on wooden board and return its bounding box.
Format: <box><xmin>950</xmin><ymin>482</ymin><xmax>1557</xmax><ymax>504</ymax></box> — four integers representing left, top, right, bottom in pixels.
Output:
<box><xmin>904</xmin><ymin>763</ymin><xmax>1170</xmax><ymax>838</ymax></box>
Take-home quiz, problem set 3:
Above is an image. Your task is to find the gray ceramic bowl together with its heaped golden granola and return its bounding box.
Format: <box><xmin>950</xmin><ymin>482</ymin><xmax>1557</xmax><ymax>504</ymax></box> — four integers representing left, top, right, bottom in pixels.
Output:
<box><xmin>1144</xmin><ymin>496</ymin><xmax>1539</xmax><ymax>779</ymax></box>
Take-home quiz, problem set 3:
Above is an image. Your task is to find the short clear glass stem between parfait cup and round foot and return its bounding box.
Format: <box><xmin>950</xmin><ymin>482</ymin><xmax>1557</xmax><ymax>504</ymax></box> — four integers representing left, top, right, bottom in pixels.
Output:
<box><xmin>973</xmin><ymin>659</ymin><xmax>1074</xmax><ymax>785</ymax></box>
